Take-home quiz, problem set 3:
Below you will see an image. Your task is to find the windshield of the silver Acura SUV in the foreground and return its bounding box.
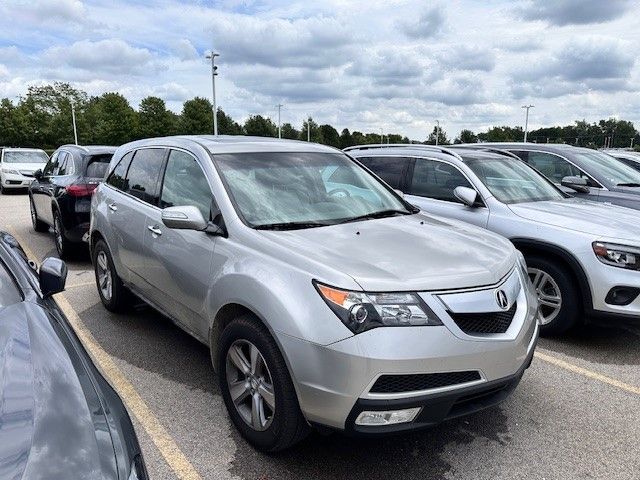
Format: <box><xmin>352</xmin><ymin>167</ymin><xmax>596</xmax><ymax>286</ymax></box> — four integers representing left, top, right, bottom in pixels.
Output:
<box><xmin>214</xmin><ymin>152</ymin><xmax>412</xmax><ymax>228</ymax></box>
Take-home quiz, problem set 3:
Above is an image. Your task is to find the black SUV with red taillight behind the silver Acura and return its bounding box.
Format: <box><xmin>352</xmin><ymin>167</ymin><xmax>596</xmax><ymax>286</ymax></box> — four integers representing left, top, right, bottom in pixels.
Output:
<box><xmin>29</xmin><ymin>145</ymin><xmax>116</xmax><ymax>259</ymax></box>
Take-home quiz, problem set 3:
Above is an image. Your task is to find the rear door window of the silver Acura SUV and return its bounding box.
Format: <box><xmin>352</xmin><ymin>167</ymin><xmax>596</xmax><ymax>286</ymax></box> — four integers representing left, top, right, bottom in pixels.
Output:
<box><xmin>126</xmin><ymin>148</ymin><xmax>165</xmax><ymax>205</ymax></box>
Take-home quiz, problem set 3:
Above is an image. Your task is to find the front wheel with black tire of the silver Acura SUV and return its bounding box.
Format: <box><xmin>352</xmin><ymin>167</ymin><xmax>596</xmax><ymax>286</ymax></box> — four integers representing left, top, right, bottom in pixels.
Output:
<box><xmin>217</xmin><ymin>314</ymin><xmax>310</xmax><ymax>452</ymax></box>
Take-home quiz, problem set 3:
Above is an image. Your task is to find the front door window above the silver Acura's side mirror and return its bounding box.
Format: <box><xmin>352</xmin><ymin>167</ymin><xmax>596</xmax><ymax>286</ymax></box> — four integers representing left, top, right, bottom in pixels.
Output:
<box><xmin>159</xmin><ymin>150</ymin><xmax>213</xmax><ymax>220</ymax></box>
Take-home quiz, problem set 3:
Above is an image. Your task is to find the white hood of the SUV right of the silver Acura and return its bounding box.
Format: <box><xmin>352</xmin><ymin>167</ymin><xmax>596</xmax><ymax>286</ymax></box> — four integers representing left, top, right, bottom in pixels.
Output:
<box><xmin>509</xmin><ymin>198</ymin><xmax>640</xmax><ymax>242</ymax></box>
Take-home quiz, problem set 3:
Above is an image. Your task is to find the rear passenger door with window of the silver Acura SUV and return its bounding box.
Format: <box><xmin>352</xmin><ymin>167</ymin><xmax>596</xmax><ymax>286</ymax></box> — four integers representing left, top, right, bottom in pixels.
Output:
<box><xmin>106</xmin><ymin>148</ymin><xmax>166</xmax><ymax>286</ymax></box>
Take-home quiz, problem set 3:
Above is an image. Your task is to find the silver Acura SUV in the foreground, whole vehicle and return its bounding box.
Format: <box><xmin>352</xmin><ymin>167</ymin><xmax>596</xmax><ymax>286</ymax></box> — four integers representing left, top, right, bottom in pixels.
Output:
<box><xmin>90</xmin><ymin>136</ymin><xmax>538</xmax><ymax>451</ymax></box>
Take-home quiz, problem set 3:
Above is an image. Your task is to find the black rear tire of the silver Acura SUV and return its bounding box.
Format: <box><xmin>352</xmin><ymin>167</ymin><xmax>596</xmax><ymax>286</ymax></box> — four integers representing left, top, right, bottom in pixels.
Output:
<box><xmin>91</xmin><ymin>240</ymin><xmax>131</xmax><ymax>313</ymax></box>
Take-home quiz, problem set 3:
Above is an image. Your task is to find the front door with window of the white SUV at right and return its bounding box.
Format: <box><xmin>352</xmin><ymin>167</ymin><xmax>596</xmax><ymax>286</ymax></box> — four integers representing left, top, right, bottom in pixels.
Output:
<box><xmin>407</xmin><ymin>158</ymin><xmax>489</xmax><ymax>228</ymax></box>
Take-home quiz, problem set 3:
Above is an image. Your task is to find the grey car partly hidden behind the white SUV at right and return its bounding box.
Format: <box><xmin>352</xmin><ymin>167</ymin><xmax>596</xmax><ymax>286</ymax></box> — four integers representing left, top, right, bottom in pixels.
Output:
<box><xmin>476</xmin><ymin>143</ymin><xmax>640</xmax><ymax>210</ymax></box>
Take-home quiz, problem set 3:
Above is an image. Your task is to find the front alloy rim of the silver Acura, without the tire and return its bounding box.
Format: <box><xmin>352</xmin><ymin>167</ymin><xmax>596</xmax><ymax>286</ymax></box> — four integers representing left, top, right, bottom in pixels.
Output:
<box><xmin>226</xmin><ymin>340</ymin><xmax>276</xmax><ymax>431</ymax></box>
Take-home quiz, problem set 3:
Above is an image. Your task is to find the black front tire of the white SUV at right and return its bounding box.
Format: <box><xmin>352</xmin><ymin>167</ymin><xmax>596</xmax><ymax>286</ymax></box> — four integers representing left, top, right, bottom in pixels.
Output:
<box><xmin>526</xmin><ymin>256</ymin><xmax>582</xmax><ymax>336</ymax></box>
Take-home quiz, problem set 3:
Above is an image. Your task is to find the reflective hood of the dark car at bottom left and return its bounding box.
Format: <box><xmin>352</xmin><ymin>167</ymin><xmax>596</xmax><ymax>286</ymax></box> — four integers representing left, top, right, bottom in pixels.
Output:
<box><xmin>0</xmin><ymin>302</ymin><xmax>117</xmax><ymax>480</ymax></box>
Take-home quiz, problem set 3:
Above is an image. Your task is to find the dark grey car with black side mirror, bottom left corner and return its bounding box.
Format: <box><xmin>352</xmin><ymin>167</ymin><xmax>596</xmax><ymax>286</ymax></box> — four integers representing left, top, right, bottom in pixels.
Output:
<box><xmin>0</xmin><ymin>232</ymin><xmax>148</xmax><ymax>480</ymax></box>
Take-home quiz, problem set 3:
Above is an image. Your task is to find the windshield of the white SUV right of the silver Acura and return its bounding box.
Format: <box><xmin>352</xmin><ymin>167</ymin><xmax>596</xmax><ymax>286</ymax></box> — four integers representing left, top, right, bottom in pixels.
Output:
<box><xmin>466</xmin><ymin>158</ymin><xmax>564</xmax><ymax>203</ymax></box>
